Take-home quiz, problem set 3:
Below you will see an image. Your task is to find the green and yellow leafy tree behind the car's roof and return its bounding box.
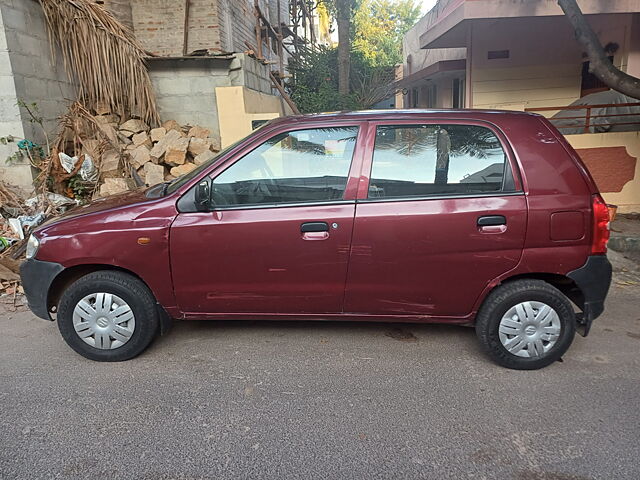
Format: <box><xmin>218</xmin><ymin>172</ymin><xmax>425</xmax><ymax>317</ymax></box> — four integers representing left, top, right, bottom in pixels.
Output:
<box><xmin>285</xmin><ymin>0</ymin><xmax>420</xmax><ymax>113</ymax></box>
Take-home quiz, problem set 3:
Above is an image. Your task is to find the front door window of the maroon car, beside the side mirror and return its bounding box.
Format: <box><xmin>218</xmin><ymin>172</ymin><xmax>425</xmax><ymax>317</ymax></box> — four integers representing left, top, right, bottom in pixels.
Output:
<box><xmin>212</xmin><ymin>126</ymin><xmax>358</xmax><ymax>207</ymax></box>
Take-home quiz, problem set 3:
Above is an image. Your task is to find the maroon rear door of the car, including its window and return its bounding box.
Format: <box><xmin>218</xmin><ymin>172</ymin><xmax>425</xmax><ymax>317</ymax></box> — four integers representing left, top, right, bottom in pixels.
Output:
<box><xmin>345</xmin><ymin>120</ymin><xmax>527</xmax><ymax>317</ymax></box>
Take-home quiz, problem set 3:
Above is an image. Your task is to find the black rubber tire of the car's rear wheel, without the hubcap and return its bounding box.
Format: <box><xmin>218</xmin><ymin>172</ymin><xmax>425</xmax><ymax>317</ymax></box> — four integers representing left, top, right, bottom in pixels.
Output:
<box><xmin>476</xmin><ymin>280</ymin><xmax>576</xmax><ymax>370</ymax></box>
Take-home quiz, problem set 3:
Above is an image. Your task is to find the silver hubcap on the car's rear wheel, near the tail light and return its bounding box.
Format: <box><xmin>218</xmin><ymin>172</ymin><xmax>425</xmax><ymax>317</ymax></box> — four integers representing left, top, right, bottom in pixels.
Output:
<box><xmin>498</xmin><ymin>302</ymin><xmax>561</xmax><ymax>358</ymax></box>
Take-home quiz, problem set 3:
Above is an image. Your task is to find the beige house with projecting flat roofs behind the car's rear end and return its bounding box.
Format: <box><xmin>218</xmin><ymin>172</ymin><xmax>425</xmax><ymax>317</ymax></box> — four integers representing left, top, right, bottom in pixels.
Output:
<box><xmin>399</xmin><ymin>0</ymin><xmax>640</xmax><ymax>212</ymax></box>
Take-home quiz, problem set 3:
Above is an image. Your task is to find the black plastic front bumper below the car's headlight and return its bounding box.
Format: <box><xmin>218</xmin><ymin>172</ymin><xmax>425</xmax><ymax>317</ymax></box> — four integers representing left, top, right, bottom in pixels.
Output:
<box><xmin>20</xmin><ymin>258</ymin><xmax>64</xmax><ymax>320</ymax></box>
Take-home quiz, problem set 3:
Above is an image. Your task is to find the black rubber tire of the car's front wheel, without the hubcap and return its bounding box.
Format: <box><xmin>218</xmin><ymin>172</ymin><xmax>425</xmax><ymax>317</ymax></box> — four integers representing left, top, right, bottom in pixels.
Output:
<box><xmin>57</xmin><ymin>270</ymin><xmax>160</xmax><ymax>362</ymax></box>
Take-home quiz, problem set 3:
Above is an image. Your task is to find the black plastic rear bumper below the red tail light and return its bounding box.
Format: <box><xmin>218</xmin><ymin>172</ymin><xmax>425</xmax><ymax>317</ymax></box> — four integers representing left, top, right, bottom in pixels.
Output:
<box><xmin>567</xmin><ymin>255</ymin><xmax>612</xmax><ymax>337</ymax></box>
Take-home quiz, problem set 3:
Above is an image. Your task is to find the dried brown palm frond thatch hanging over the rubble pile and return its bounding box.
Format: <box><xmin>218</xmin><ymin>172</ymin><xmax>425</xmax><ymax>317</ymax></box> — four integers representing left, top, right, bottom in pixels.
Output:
<box><xmin>39</xmin><ymin>0</ymin><xmax>158</xmax><ymax>125</ymax></box>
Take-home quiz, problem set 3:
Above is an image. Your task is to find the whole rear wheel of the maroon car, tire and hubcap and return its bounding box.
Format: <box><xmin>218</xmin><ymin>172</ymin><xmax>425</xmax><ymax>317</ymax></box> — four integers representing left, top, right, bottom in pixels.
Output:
<box><xmin>476</xmin><ymin>280</ymin><xmax>575</xmax><ymax>370</ymax></box>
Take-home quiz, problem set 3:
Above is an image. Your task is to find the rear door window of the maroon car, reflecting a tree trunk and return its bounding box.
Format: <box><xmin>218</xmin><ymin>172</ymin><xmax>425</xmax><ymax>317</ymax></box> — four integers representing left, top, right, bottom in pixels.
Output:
<box><xmin>368</xmin><ymin>124</ymin><xmax>513</xmax><ymax>199</ymax></box>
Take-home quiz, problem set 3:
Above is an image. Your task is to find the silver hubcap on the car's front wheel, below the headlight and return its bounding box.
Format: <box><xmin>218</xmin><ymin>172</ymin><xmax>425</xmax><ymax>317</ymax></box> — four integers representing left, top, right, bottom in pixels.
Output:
<box><xmin>73</xmin><ymin>293</ymin><xmax>136</xmax><ymax>350</ymax></box>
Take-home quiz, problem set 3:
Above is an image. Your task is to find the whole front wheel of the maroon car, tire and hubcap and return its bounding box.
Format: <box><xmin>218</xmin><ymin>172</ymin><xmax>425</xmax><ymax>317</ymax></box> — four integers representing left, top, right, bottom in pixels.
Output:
<box><xmin>58</xmin><ymin>271</ymin><xmax>159</xmax><ymax>362</ymax></box>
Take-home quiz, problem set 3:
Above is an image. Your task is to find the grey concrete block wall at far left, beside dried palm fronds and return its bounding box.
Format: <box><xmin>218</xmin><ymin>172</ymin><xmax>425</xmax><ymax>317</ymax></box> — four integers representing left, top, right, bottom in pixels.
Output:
<box><xmin>0</xmin><ymin>0</ymin><xmax>75</xmax><ymax>190</ymax></box>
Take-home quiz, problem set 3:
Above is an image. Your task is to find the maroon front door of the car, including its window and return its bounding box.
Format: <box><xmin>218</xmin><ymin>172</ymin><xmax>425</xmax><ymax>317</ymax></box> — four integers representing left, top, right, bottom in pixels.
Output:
<box><xmin>170</xmin><ymin>123</ymin><xmax>359</xmax><ymax>316</ymax></box>
